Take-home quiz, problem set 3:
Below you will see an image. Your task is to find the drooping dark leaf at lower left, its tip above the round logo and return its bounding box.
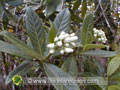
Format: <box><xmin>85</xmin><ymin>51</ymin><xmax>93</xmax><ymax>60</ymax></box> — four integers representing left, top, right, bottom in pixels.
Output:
<box><xmin>5</xmin><ymin>60</ymin><xmax>34</xmax><ymax>85</ymax></box>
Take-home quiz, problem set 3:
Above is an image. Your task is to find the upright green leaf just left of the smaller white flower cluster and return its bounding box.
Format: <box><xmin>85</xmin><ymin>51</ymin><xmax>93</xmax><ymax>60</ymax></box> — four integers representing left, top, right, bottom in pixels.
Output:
<box><xmin>81</xmin><ymin>12</ymin><xmax>94</xmax><ymax>45</ymax></box>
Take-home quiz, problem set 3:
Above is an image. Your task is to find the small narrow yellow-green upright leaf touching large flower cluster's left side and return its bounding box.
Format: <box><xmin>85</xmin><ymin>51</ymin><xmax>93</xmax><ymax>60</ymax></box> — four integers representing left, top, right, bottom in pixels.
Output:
<box><xmin>49</xmin><ymin>22</ymin><xmax>56</xmax><ymax>43</ymax></box>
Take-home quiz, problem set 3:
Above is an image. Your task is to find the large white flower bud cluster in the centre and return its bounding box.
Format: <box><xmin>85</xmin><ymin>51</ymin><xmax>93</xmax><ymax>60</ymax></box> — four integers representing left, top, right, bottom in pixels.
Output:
<box><xmin>47</xmin><ymin>32</ymin><xmax>78</xmax><ymax>54</ymax></box>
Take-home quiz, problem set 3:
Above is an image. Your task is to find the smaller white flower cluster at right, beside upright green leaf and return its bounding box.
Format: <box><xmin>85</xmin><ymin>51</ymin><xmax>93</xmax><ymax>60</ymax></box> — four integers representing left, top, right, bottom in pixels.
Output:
<box><xmin>93</xmin><ymin>28</ymin><xmax>107</xmax><ymax>43</ymax></box>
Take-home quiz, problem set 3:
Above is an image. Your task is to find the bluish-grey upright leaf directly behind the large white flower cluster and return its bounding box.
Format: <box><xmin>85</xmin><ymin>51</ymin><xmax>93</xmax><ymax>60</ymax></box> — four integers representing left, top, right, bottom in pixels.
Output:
<box><xmin>54</xmin><ymin>8</ymin><xmax>70</xmax><ymax>34</ymax></box>
